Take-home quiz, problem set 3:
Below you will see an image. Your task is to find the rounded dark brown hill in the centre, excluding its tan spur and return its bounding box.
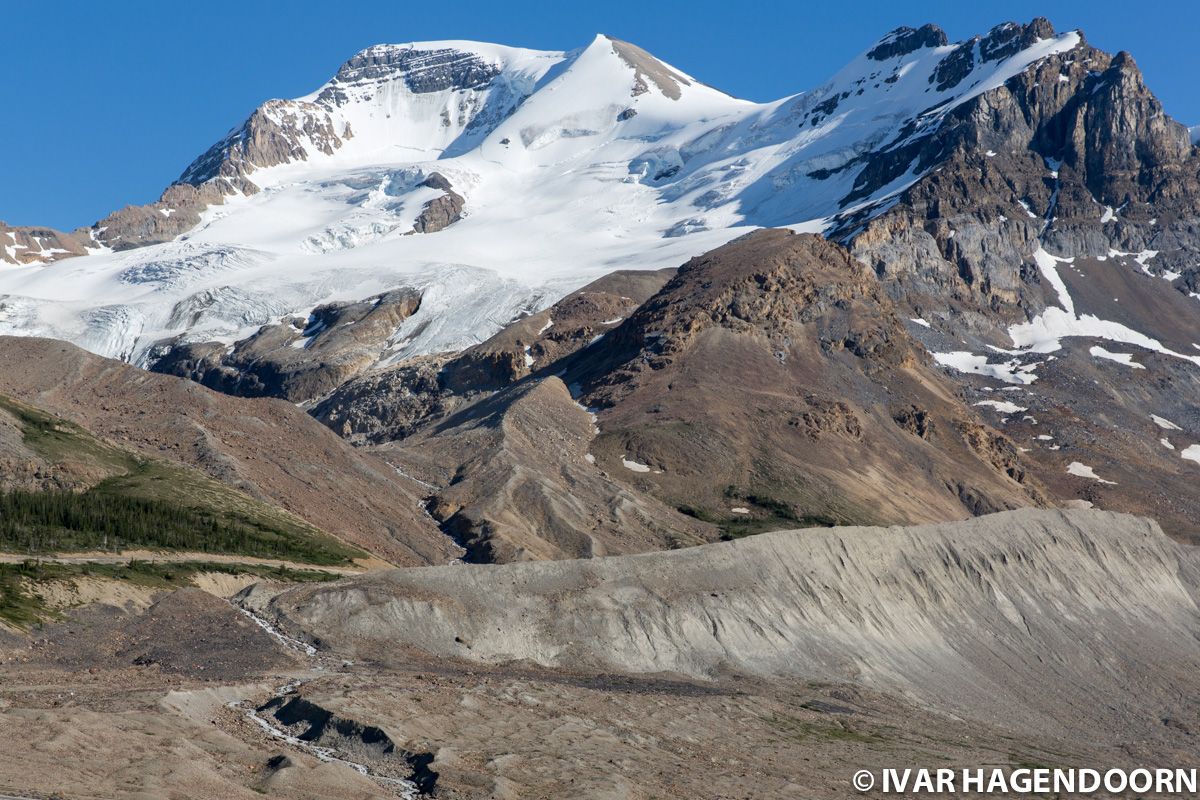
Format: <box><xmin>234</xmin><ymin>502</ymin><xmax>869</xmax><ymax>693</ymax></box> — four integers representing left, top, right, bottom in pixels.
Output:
<box><xmin>554</xmin><ymin>230</ymin><xmax>1044</xmax><ymax>530</ymax></box>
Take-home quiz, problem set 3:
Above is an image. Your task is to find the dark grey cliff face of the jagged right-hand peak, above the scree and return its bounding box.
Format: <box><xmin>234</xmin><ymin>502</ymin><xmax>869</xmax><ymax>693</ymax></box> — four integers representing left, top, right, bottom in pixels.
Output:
<box><xmin>834</xmin><ymin>20</ymin><xmax>1200</xmax><ymax>333</ymax></box>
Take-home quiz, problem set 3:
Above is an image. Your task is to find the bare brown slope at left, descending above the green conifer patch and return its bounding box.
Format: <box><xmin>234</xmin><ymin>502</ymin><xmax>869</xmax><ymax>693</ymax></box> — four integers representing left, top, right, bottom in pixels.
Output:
<box><xmin>0</xmin><ymin>337</ymin><xmax>458</xmax><ymax>565</ymax></box>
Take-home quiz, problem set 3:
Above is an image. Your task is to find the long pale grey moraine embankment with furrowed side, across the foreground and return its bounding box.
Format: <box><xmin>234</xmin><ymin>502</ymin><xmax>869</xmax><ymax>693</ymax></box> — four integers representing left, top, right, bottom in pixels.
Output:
<box><xmin>245</xmin><ymin>510</ymin><xmax>1200</xmax><ymax>743</ymax></box>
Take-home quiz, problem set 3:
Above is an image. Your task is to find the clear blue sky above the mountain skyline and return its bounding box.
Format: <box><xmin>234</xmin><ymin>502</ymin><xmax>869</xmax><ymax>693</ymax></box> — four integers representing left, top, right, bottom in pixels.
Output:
<box><xmin>0</xmin><ymin>0</ymin><xmax>1200</xmax><ymax>229</ymax></box>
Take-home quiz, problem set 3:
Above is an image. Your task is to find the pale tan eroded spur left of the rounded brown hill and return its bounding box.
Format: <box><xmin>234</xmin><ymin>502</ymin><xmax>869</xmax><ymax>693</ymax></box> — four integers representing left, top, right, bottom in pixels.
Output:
<box><xmin>379</xmin><ymin>378</ymin><xmax>718</xmax><ymax>561</ymax></box>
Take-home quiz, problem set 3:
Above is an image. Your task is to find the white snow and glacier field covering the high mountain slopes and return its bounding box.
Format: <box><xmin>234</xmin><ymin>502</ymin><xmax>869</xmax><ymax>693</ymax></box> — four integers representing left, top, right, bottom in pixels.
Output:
<box><xmin>0</xmin><ymin>32</ymin><xmax>1080</xmax><ymax>362</ymax></box>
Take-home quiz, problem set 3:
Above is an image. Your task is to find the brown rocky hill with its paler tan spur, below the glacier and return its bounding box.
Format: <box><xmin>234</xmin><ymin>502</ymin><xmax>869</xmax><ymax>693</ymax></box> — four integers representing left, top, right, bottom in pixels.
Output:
<box><xmin>326</xmin><ymin>230</ymin><xmax>1049</xmax><ymax>561</ymax></box>
